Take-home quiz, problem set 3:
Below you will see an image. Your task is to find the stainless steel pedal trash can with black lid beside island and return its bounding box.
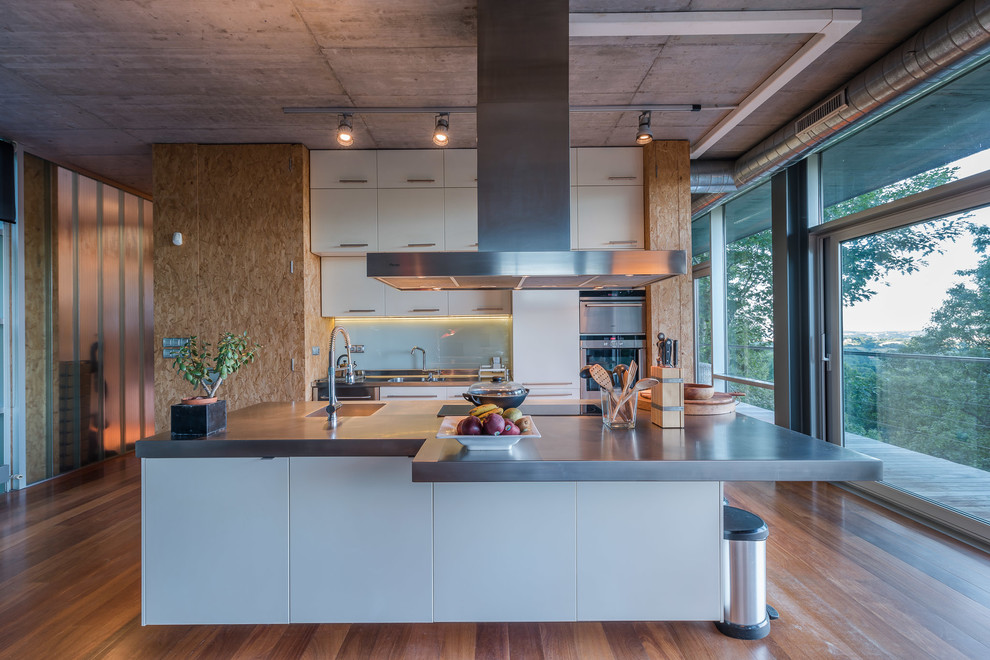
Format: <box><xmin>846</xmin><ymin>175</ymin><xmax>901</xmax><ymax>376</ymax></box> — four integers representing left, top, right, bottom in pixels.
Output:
<box><xmin>715</xmin><ymin>506</ymin><xmax>777</xmax><ymax>639</ymax></box>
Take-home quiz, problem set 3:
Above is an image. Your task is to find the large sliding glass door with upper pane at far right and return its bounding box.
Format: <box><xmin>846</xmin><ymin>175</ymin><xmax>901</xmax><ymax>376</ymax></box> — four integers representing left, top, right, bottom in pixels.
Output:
<box><xmin>814</xmin><ymin>56</ymin><xmax>990</xmax><ymax>540</ymax></box>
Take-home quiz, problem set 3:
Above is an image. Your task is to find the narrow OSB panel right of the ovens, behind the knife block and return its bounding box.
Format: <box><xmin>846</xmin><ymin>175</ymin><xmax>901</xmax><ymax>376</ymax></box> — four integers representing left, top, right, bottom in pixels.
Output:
<box><xmin>643</xmin><ymin>140</ymin><xmax>695</xmax><ymax>382</ymax></box>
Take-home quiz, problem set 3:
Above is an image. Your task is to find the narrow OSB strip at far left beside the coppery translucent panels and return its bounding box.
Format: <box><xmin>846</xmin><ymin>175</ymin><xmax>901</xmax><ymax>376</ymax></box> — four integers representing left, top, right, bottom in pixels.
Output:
<box><xmin>23</xmin><ymin>154</ymin><xmax>58</xmax><ymax>484</ymax></box>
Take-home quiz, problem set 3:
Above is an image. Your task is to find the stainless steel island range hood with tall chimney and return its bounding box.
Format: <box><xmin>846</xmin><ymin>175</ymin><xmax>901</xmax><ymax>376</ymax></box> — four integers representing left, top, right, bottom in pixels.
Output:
<box><xmin>368</xmin><ymin>0</ymin><xmax>687</xmax><ymax>290</ymax></box>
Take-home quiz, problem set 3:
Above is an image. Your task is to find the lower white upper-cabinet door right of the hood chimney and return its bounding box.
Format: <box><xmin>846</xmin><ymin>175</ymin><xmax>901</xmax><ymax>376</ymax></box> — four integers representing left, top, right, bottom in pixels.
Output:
<box><xmin>577</xmin><ymin>186</ymin><xmax>645</xmax><ymax>250</ymax></box>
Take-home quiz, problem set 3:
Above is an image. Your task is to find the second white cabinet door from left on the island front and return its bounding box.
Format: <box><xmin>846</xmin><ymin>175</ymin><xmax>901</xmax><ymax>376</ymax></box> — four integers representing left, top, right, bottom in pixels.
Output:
<box><xmin>289</xmin><ymin>457</ymin><xmax>433</xmax><ymax>623</ymax></box>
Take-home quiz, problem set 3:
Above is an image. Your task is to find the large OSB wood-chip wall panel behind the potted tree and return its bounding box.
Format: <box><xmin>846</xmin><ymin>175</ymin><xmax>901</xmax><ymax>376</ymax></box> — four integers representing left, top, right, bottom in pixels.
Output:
<box><xmin>154</xmin><ymin>144</ymin><xmax>319</xmax><ymax>431</ymax></box>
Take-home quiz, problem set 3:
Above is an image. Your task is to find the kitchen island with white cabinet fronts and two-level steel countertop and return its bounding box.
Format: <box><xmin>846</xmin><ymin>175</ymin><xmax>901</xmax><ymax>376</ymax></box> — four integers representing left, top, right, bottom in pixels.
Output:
<box><xmin>137</xmin><ymin>401</ymin><xmax>881</xmax><ymax>624</ymax></box>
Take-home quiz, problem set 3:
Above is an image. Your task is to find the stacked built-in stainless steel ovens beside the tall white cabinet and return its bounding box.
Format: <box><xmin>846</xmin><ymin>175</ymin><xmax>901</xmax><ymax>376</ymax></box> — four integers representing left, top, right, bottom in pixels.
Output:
<box><xmin>579</xmin><ymin>289</ymin><xmax>647</xmax><ymax>398</ymax></box>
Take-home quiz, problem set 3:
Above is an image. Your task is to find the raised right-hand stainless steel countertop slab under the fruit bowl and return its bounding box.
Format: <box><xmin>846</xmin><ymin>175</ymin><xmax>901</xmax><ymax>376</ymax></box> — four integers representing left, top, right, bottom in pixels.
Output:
<box><xmin>413</xmin><ymin>406</ymin><xmax>883</xmax><ymax>482</ymax></box>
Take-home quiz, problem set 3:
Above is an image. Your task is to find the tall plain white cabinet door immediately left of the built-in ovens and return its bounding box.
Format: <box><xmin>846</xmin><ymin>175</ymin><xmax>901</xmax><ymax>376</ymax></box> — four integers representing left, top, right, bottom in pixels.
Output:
<box><xmin>512</xmin><ymin>291</ymin><xmax>581</xmax><ymax>392</ymax></box>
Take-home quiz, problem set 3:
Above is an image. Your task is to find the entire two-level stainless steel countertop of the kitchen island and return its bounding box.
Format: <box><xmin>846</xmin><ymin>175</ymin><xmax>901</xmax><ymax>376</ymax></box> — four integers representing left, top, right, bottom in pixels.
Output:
<box><xmin>136</xmin><ymin>401</ymin><xmax>883</xmax><ymax>482</ymax></box>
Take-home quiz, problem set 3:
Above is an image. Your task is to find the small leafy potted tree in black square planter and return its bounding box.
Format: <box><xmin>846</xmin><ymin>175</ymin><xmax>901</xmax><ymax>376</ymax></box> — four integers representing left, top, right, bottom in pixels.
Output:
<box><xmin>172</xmin><ymin>332</ymin><xmax>261</xmax><ymax>438</ymax></box>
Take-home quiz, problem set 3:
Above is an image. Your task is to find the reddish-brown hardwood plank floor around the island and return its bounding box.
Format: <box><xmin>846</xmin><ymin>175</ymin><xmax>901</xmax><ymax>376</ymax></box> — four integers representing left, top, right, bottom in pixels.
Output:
<box><xmin>0</xmin><ymin>455</ymin><xmax>990</xmax><ymax>660</ymax></box>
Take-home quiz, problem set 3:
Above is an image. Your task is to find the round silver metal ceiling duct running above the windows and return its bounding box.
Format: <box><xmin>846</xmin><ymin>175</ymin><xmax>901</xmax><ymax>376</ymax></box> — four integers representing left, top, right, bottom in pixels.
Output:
<box><xmin>692</xmin><ymin>0</ymin><xmax>990</xmax><ymax>214</ymax></box>
